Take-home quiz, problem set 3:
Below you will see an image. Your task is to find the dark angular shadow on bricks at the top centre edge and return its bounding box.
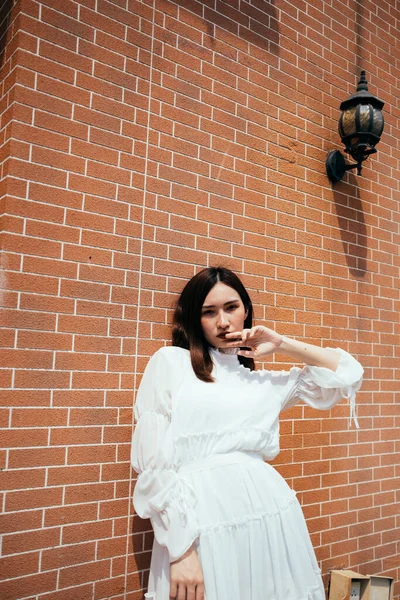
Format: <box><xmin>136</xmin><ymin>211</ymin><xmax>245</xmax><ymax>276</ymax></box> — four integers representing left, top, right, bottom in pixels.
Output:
<box><xmin>201</xmin><ymin>0</ymin><xmax>279</xmax><ymax>55</ymax></box>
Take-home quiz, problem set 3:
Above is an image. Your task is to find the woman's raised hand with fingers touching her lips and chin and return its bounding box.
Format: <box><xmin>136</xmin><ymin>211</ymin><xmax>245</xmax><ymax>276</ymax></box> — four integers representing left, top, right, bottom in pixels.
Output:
<box><xmin>225</xmin><ymin>325</ymin><xmax>283</xmax><ymax>360</ymax></box>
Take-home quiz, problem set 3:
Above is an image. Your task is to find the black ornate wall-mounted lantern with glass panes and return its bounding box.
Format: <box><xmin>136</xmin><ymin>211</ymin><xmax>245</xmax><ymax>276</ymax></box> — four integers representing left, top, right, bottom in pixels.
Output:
<box><xmin>326</xmin><ymin>71</ymin><xmax>384</xmax><ymax>183</ymax></box>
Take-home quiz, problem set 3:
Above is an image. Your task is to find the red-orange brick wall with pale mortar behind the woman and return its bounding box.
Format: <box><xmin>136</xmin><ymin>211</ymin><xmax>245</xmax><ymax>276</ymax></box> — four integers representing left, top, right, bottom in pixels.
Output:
<box><xmin>0</xmin><ymin>0</ymin><xmax>400</xmax><ymax>600</ymax></box>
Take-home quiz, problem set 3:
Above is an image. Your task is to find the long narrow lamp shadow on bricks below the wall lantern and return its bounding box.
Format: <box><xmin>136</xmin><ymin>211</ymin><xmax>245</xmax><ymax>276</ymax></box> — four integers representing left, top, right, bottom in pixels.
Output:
<box><xmin>333</xmin><ymin>173</ymin><xmax>368</xmax><ymax>279</ymax></box>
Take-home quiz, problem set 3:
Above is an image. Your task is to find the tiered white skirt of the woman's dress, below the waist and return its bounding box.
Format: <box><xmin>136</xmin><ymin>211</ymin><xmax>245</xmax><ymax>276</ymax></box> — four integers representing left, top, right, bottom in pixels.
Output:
<box><xmin>149</xmin><ymin>452</ymin><xmax>325</xmax><ymax>600</ymax></box>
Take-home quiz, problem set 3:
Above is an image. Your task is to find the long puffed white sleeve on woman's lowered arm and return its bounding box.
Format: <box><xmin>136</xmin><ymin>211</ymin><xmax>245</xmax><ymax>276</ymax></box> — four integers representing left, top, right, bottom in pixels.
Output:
<box><xmin>131</xmin><ymin>348</ymin><xmax>198</xmax><ymax>562</ymax></box>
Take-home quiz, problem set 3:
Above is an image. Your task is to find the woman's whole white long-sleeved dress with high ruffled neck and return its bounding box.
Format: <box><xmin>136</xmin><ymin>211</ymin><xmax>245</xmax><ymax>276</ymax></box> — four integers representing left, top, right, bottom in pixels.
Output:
<box><xmin>132</xmin><ymin>347</ymin><xmax>363</xmax><ymax>600</ymax></box>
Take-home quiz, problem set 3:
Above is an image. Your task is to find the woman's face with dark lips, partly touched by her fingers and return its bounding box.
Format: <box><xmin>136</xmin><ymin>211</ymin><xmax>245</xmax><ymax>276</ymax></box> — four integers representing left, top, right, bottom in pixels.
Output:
<box><xmin>201</xmin><ymin>281</ymin><xmax>247</xmax><ymax>348</ymax></box>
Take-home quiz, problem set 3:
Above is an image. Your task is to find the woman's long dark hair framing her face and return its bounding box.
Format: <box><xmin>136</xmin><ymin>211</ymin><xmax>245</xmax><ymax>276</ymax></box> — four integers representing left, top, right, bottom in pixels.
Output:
<box><xmin>172</xmin><ymin>267</ymin><xmax>254</xmax><ymax>382</ymax></box>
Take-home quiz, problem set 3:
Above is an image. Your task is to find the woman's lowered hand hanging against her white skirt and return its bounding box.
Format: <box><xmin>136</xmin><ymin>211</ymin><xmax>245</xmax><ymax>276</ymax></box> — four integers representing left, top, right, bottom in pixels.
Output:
<box><xmin>169</xmin><ymin>546</ymin><xmax>204</xmax><ymax>600</ymax></box>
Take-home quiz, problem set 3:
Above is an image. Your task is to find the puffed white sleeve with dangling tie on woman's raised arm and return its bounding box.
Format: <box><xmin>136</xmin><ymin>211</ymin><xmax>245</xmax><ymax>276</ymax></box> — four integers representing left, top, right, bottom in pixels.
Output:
<box><xmin>281</xmin><ymin>348</ymin><xmax>364</xmax><ymax>429</ymax></box>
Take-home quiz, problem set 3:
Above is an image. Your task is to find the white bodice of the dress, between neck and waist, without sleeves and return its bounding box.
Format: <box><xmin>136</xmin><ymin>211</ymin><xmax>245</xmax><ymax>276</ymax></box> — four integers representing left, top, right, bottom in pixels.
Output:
<box><xmin>172</xmin><ymin>350</ymin><xmax>288</xmax><ymax>464</ymax></box>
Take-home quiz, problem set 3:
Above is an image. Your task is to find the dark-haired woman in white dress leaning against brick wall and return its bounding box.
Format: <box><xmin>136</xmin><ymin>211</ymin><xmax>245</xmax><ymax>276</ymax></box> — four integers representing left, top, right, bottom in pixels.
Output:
<box><xmin>132</xmin><ymin>268</ymin><xmax>363</xmax><ymax>600</ymax></box>
